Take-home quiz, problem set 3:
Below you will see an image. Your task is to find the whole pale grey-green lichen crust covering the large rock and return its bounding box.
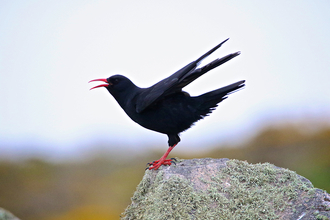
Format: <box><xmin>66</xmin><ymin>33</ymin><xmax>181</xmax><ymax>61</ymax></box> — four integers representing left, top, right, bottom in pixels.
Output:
<box><xmin>122</xmin><ymin>160</ymin><xmax>314</xmax><ymax>219</ymax></box>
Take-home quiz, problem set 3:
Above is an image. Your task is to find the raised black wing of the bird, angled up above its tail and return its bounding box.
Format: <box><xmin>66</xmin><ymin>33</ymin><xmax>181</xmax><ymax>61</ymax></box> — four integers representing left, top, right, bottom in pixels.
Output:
<box><xmin>136</xmin><ymin>38</ymin><xmax>240</xmax><ymax>113</ymax></box>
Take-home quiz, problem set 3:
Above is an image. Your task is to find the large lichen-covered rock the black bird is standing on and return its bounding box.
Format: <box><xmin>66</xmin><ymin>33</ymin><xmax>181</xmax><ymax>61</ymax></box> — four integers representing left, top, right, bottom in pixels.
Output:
<box><xmin>122</xmin><ymin>158</ymin><xmax>330</xmax><ymax>220</ymax></box>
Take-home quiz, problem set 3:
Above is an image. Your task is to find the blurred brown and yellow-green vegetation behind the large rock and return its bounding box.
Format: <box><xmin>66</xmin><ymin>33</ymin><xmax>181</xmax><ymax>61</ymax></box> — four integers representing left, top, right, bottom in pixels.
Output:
<box><xmin>0</xmin><ymin>124</ymin><xmax>330</xmax><ymax>220</ymax></box>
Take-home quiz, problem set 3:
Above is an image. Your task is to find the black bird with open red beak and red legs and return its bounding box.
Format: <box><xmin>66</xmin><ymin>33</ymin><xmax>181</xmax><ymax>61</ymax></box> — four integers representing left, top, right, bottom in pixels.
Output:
<box><xmin>90</xmin><ymin>39</ymin><xmax>245</xmax><ymax>170</ymax></box>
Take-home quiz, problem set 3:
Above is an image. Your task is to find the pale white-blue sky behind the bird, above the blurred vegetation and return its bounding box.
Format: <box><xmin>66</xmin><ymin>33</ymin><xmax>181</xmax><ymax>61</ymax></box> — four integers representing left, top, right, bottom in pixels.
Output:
<box><xmin>0</xmin><ymin>0</ymin><xmax>330</xmax><ymax>160</ymax></box>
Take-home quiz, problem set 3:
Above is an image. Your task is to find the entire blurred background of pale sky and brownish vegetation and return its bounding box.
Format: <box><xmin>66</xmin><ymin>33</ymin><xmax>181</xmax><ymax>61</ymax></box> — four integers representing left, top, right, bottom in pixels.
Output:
<box><xmin>0</xmin><ymin>0</ymin><xmax>330</xmax><ymax>220</ymax></box>
